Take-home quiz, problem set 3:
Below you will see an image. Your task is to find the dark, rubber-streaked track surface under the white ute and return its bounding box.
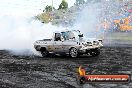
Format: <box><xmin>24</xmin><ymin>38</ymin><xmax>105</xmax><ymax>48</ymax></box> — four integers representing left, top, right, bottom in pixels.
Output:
<box><xmin>0</xmin><ymin>46</ymin><xmax>132</xmax><ymax>88</ymax></box>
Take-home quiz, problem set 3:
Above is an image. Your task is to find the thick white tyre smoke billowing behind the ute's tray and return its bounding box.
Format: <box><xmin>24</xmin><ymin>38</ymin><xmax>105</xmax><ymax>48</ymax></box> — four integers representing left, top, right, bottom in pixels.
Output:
<box><xmin>0</xmin><ymin>12</ymin><xmax>64</xmax><ymax>53</ymax></box>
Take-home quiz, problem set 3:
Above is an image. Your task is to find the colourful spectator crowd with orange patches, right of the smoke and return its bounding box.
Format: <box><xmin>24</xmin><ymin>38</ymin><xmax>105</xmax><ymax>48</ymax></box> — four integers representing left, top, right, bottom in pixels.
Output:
<box><xmin>100</xmin><ymin>1</ymin><xmax>132</xmax><ymax>31</ymax></box>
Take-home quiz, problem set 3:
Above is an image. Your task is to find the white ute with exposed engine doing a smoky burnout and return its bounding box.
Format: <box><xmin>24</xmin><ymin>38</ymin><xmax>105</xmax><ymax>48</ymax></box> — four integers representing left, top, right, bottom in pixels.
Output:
<box><xmin>34</xmin><ymin>30</ymin><xmax>103</xmax><ymax>58</ymax></box>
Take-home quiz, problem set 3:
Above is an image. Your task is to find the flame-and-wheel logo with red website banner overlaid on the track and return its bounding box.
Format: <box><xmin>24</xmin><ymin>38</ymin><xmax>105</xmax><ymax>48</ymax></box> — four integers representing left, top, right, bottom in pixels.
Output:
<box><xmin>78</xmin><ymin>66</ymin><xmax>131</xmax><ymax>84</ymax></box>
